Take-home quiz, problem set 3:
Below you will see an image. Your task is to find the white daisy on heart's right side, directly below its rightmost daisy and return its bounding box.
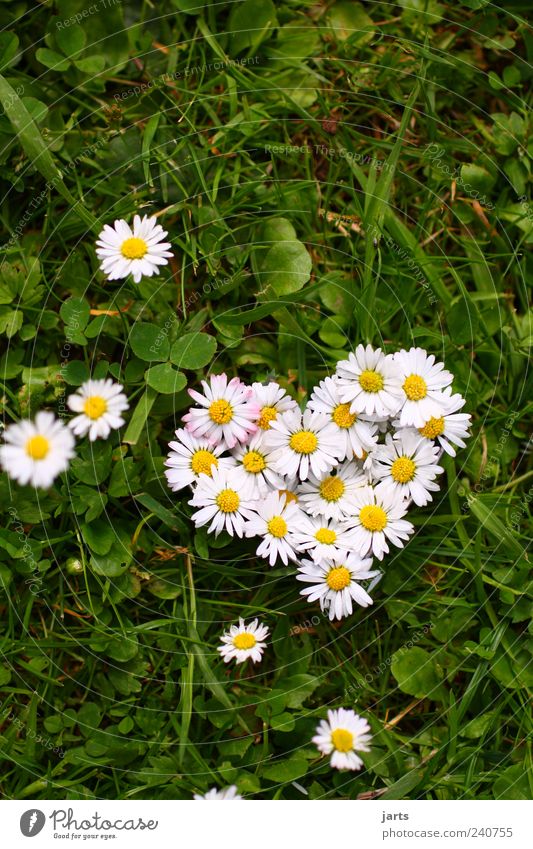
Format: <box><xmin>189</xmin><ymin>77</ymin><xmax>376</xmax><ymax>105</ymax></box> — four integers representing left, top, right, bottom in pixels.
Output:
<box><xmin>373</xmin><ymin>428</ymin><xmax>444</xmax><ymax>507</ymax></box>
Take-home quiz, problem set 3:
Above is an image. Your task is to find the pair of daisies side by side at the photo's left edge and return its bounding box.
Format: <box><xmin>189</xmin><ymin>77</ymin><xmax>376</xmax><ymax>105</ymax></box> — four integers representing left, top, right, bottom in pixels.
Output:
<box><xmin>0</xmin><ymin>378</ymin><xmax>129</xmax><ymax>489</ymax></box>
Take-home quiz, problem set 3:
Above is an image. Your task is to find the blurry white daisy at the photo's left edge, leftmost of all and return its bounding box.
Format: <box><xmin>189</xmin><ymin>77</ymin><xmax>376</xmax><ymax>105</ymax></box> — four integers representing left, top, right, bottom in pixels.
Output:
<box><xmin>0</xmin><ymin>411</ymin><xmax>74</xmax><ymax>489</ymax></box>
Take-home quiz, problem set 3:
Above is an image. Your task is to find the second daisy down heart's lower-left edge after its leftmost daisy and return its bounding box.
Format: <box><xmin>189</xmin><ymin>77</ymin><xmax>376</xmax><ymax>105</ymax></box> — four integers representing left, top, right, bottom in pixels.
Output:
<box><xmin>244</xmin><ymin>492</ymin><xmax>307</xmax><ymax>566</ymax></box>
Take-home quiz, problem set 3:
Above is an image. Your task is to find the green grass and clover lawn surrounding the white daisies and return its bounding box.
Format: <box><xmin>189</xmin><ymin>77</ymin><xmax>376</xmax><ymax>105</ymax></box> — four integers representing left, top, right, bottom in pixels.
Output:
<box><xmin>0</xmin><ymin>0</ymin><xmax>533</xmax><ymax>799</ymax></box>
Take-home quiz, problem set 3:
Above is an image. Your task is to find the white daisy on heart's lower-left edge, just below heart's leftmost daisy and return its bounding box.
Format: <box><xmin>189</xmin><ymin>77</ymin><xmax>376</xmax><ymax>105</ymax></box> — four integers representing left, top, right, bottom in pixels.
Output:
<box><xmin>189</xmin><ymin>466</ymin><xmax>255</xmax><ymax>537</ymax></box>
